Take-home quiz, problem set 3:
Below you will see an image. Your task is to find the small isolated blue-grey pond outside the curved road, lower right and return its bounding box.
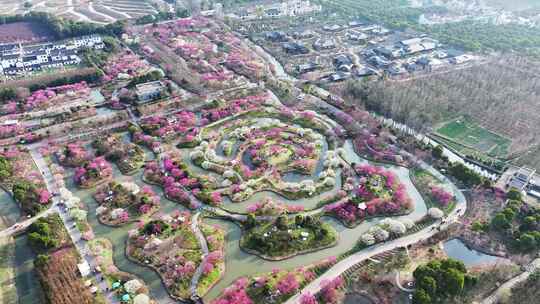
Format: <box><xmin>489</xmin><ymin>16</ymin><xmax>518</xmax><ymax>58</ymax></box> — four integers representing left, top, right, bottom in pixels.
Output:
<box><xmin>443</xmin><ymin>239</ymin><xmax>505</xmax><ymax>267</ymax></box>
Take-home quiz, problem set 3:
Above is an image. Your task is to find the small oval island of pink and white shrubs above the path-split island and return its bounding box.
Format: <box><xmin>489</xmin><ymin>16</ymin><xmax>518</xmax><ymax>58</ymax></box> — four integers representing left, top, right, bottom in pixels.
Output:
<box><xmin>94</xmin><ymin>182</ymin><xmax>160</xmax><ymax>226</ymax></box>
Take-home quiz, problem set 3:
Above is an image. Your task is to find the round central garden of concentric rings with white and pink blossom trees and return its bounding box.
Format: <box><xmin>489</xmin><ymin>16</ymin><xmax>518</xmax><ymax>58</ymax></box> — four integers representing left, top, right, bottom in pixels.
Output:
<box><xmin>190</xmin><ymin>96</ymin><xmax>340</xmax><ymax>202</ymax></box>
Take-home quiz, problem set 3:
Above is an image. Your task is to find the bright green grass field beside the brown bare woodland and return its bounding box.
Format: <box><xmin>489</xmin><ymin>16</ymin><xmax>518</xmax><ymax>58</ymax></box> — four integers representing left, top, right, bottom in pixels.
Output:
<box><xmin>435</xmin><ymin>118</ymin><xmax>512</xmax><ymax>158</ymax></box>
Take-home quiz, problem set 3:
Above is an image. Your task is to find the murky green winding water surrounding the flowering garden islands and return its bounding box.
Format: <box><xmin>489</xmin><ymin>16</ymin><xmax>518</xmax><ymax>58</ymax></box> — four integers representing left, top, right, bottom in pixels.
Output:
<box><xmin>61</xmin><ymin>136</ymin><xmax>436</xmax><ymax>302</ymax></box>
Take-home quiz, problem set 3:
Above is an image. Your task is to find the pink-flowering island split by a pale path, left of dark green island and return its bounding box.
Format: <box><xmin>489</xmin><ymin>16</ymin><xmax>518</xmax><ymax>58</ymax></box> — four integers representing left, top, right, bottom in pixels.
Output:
<box><xmin>126</xmin><ymin>212</ymin><xmax>224</xmax><ymax>300</ymax></box>
